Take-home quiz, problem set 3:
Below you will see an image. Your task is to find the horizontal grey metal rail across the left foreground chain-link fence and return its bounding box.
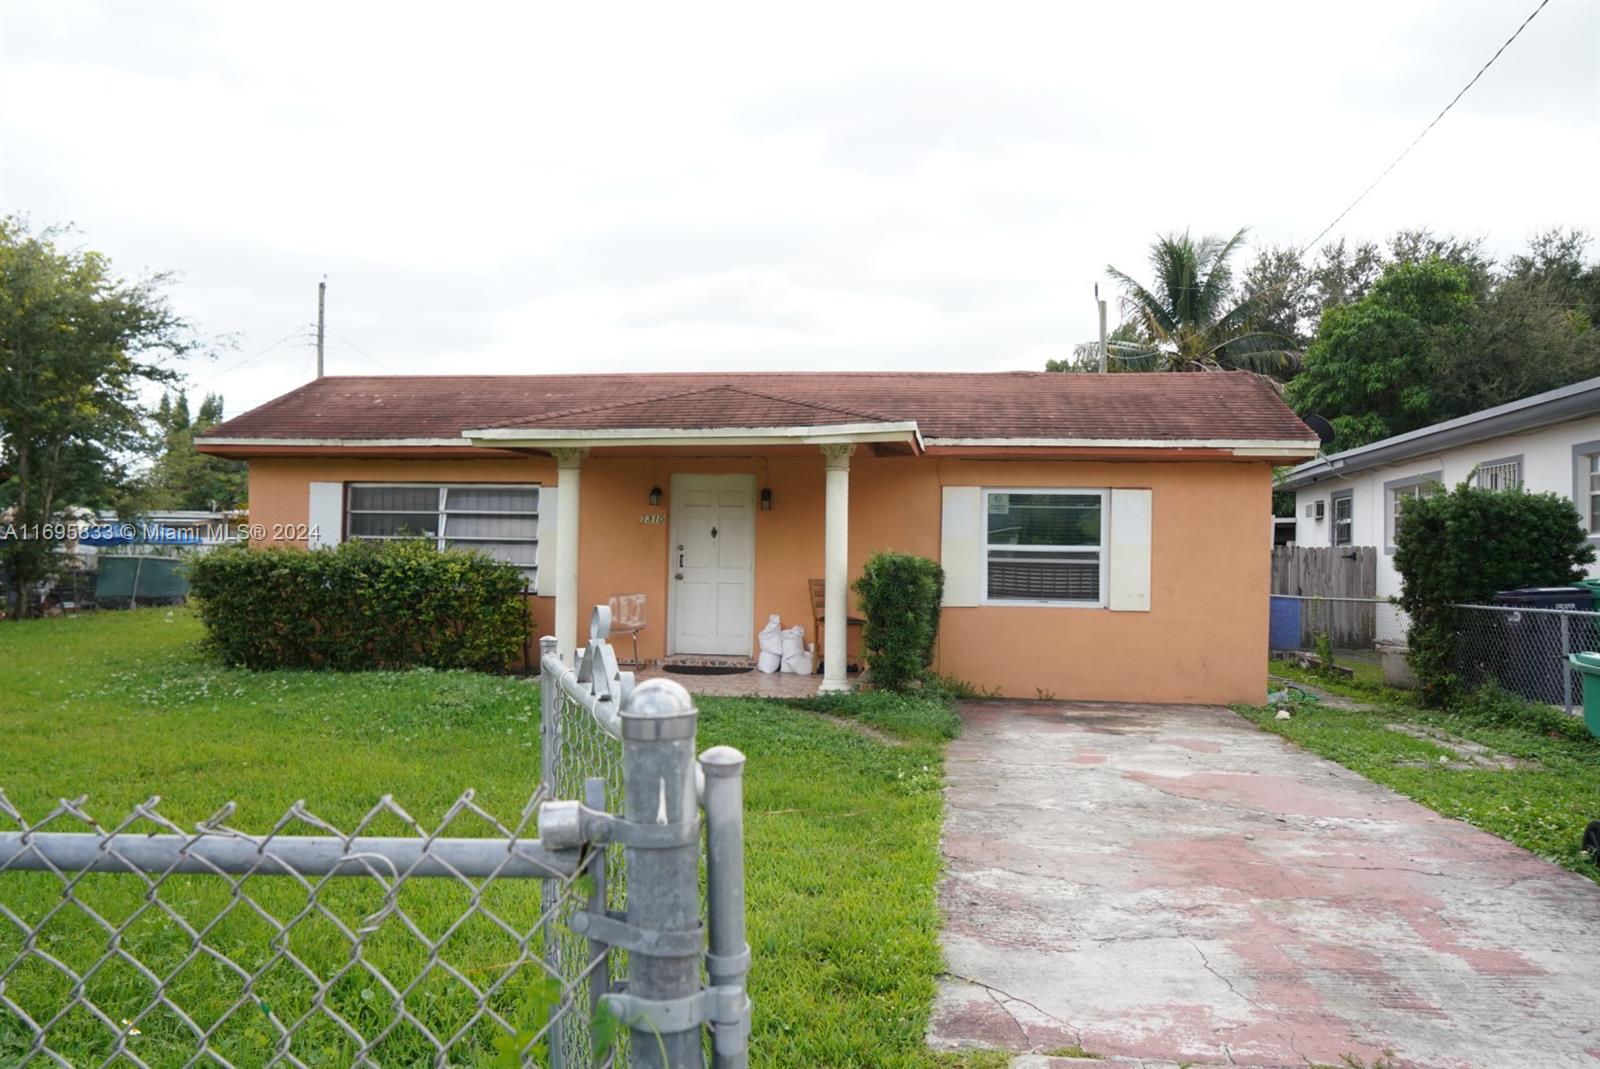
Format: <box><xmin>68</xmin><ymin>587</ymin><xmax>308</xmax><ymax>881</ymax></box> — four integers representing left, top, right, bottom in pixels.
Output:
<box><xmin>0</xmin><ymin>831</ymin><xmax>579</xmax><ymax>880</ymax></box>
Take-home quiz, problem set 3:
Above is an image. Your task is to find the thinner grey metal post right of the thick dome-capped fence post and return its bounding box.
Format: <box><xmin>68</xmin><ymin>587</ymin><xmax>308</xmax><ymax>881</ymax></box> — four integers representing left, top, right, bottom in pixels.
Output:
<box><xmin>701</xmin><ymin>746</ymin><xmax>750</xmax><ymax>1069</ymax></box>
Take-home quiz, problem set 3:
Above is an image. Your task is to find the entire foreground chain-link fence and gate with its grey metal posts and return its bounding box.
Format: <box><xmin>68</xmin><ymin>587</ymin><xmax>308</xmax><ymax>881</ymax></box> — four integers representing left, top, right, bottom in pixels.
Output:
<box><xmin>0</xmin><ymin>607</ymin><xmax>750</xmax><ymax>1069</ymax></box>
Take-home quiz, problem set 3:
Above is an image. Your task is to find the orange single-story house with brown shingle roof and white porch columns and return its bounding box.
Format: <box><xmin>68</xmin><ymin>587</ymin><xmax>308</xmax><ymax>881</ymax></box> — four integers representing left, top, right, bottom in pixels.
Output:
<box><xmin>197</xmin><ymin>373</ymin><xmax>1317</xmax><ymax>703</ymax></box>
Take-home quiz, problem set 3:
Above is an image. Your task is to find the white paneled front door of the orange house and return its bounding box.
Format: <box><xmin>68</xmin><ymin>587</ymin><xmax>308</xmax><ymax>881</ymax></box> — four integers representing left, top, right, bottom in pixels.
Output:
<box><xmin>667</xmin><ymin>475</ymin><xmax>755</xmax><ymax>656</ymax></box>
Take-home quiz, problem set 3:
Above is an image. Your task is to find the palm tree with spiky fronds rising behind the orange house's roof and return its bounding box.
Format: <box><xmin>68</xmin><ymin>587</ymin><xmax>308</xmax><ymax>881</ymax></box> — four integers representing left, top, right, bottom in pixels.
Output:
<box><xmin>1106</xmin><ymin>229</ymin><xmax>1299</xmax><ymax>374</ymax></box>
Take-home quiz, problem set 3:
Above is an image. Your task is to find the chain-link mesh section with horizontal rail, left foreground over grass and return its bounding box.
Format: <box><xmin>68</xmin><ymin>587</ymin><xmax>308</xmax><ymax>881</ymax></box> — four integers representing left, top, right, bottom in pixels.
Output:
<box><xmin>0</xmin><ymin>792</ymin><xmax>581</xmax><ymax>1066</ymax></box>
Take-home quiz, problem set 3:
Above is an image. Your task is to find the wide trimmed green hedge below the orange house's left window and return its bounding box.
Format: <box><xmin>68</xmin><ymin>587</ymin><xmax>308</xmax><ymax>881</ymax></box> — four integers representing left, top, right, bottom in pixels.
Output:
<box><xmin>187</xmin><ymin>539</ymin><xmax>528</xmax><ymax>672</ymax></box>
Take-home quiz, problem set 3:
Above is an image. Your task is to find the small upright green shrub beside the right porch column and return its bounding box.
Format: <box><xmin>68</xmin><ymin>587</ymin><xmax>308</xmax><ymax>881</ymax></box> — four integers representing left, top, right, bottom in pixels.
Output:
<box><xmin>856</xmin><ymin>552</ymin><xmax>944</xmax><ymax>690</ymax></box>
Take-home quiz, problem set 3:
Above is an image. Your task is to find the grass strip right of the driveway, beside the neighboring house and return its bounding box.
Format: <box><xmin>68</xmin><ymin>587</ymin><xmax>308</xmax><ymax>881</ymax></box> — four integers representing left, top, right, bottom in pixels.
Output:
<box><xmin>1238</xmin><ymin>675</ymin><xmax>1600</xmax><ymax>882</ymax></box>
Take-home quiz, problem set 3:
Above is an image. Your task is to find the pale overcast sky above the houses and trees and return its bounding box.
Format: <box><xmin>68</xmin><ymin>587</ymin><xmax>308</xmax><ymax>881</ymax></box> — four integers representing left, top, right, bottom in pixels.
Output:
<box><xmin>0</xmin><ymin>0</ymin><xmax>1600</xmax><ymax>414</ymax></box>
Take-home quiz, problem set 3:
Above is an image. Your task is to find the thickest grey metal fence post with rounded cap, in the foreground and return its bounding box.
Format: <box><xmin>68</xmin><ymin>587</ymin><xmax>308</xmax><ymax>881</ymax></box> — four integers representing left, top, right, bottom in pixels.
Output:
<box><xmin>608</xmin><ymin>679</ymin><xmax>704</xmax><ymax>1069</ymax></box>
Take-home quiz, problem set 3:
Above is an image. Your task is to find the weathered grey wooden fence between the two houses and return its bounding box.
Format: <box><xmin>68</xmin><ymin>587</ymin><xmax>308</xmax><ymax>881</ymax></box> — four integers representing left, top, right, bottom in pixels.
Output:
<box><xmin>1272</xmin><ymin>546</ymin><xmax>1378</xmax><ymax>650</ymax></box>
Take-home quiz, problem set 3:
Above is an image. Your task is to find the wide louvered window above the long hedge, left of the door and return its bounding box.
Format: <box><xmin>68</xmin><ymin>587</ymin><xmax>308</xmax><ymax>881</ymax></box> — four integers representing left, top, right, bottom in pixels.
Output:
<box><xmin>349</xmin><ymin>483</ymin><xmax>539</xmax><ymax>581</ymax></box>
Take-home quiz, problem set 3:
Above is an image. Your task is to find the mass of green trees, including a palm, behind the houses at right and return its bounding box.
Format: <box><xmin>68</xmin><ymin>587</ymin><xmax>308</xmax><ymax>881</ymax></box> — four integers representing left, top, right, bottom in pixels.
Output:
<box><xmin>1046</xmin><ymin>229</ymin><xmax>1600</xmax><ymax>448</ymax></box>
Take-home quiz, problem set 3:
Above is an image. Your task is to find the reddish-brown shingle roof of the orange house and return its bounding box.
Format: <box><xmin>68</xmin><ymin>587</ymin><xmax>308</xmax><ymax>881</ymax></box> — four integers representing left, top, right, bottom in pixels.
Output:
<box><xmin>205</xmin><ymin>371</ymin><xmax>1317</xmax><ymax>443</ymax></box>
